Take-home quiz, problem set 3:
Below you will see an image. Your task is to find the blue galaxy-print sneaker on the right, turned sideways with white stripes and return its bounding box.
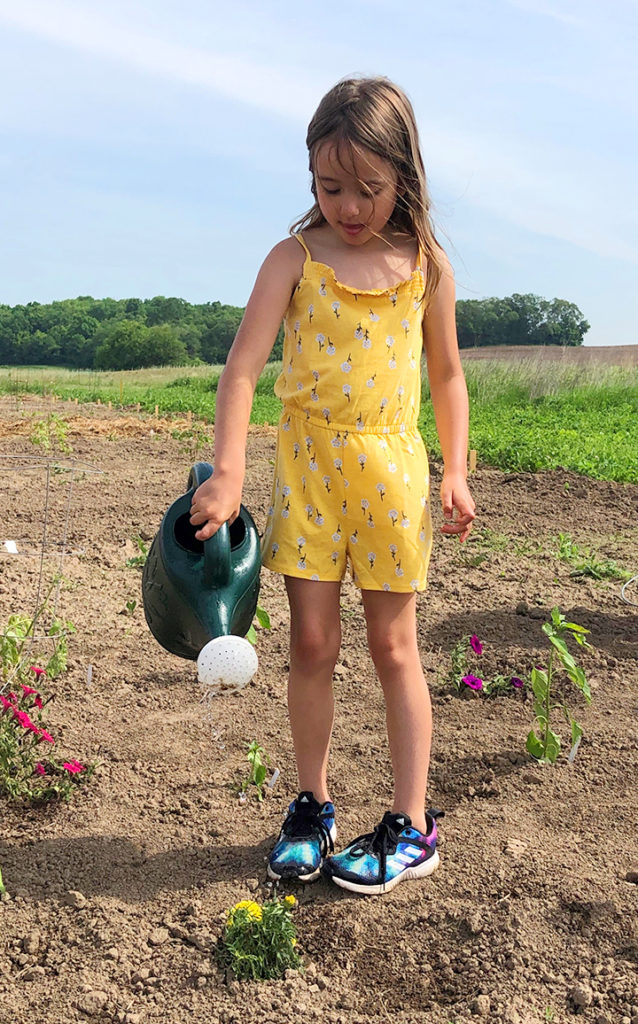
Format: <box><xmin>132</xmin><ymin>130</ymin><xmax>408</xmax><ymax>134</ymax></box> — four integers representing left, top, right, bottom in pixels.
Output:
<box><xmin>322</xmin><ymin>811</ymin><xmax>442</xmax><ymax>895</ymax></box>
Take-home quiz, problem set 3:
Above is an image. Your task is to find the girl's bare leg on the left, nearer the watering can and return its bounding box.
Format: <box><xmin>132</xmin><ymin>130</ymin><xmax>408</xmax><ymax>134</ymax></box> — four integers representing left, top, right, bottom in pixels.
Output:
<box><xmin>286</xmin><ymin>577</ymin><xmax>341</xmax><ymax>803</ymax></box>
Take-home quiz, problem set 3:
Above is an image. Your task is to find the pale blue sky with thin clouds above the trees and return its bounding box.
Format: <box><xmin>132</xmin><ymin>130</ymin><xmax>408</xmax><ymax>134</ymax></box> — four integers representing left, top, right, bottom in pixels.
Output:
<box><xmin>0</xmin><ymin>0</ymin><xmax>638</xmax><ymax>345</ymax></box>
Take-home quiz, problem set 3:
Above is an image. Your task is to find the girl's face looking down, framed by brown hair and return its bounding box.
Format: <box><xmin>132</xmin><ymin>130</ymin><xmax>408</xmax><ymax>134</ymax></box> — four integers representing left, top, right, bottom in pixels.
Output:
<box><xmin>314</xmin><ymin>139</ymin><xmax>397</xmax><ymax>246</ymax></box>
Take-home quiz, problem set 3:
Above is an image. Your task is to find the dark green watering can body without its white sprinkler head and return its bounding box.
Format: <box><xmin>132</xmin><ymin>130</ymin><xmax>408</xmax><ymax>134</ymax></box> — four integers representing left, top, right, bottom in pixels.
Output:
<box><xmin>141</xmin><ymin>462</ymin><xmax>261</xmax><ymax>660</ymax></box>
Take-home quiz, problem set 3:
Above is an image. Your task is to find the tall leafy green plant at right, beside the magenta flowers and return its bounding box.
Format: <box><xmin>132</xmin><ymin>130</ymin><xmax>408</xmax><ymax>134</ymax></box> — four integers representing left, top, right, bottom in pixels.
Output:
<box><xmin>525</xmin><ymin>608</ymin><xmax>592</xmax><ymax>764</ymax></box>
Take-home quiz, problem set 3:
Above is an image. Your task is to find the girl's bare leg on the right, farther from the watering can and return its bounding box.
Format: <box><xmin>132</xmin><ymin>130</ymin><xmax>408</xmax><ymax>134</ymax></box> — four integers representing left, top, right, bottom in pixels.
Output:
<box><xmin>361</xmin><ymin>590</ymin><xmax>432</xmax><ymax>831</ymax></box>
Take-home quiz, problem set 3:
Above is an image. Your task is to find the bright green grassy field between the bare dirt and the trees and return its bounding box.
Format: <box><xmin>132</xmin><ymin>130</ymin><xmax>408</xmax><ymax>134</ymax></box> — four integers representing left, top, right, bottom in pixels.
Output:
<box><xmin>0</xmin><ymin>359</ymin><xmax>638</xmax><ymax>483</ymax></box>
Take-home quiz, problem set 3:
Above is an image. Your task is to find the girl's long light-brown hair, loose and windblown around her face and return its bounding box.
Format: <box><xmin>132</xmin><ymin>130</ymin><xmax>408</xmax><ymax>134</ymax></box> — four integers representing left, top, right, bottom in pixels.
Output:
<box><xmin>290</xmin><ymin>78</ymin><xmax>442</xmax><ymax>305</ymax></box>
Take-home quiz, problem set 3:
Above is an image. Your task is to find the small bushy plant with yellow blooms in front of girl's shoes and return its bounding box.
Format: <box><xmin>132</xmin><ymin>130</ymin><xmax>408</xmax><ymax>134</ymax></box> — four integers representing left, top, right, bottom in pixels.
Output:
<box><xmin>217</xmin><ymin>896</ymin><xmax>301</xmax><ymax>981</ymax></box>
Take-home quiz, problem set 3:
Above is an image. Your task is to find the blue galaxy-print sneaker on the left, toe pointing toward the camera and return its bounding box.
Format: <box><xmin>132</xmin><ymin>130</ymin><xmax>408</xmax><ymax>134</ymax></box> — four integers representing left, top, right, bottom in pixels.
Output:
<box><xmin>268</xmin><ymin>792</ymin><xmax>337</xmax><ymax>882</ymax></box>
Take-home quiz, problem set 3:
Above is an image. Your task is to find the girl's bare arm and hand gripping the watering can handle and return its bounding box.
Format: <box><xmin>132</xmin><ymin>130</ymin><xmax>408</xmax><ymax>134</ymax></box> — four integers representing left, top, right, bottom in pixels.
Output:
<box><xmin>190</xmin><ymin>239</ymin><xmax>303</xmax><ymax>541</ymax></box>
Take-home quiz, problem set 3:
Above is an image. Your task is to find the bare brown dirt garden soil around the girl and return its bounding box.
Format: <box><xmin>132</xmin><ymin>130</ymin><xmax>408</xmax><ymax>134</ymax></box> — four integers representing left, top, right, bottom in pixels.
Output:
<box><xmin>0</xmin><ymin>409</ymin><xmax>638</xmax><ymax>1024</ymax></box>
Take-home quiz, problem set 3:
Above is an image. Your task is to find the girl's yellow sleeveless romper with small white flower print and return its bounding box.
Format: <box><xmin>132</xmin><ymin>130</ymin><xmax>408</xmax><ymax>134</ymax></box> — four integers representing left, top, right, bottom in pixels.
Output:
<box><xmin>261</xmin><ymin>233</ymin><xmax>432</xmax><ymax>592</ymax></box>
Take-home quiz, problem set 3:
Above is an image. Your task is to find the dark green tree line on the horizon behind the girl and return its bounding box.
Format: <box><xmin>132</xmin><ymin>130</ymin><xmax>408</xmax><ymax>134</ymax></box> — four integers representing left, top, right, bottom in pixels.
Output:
<box><xmin>0</xmin><ymin>295</ymin><xmax>589</xmax><ymax>370</ymax></box>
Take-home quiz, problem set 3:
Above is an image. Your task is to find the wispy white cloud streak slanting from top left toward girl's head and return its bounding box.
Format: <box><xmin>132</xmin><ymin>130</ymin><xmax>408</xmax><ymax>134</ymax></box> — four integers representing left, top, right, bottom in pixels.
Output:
<box><xmin>0</xmin><ymin>0</ymin><xmax>321</xmax><ymax>121</ymax></box>
